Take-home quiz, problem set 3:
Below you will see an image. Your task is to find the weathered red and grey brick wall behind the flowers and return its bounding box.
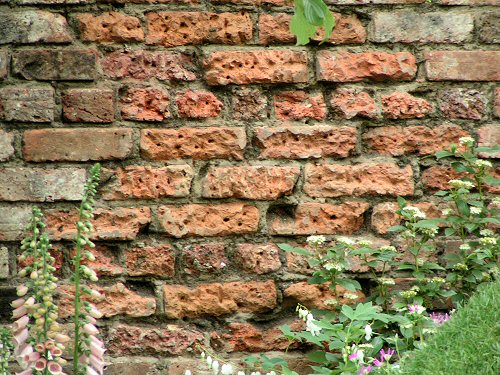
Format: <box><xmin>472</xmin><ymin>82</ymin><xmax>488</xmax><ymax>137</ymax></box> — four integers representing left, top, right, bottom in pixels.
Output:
<box><xmin>0</xmin><ymin>0</ymin><xmax>500</xmax><ymax>374</ymax></box>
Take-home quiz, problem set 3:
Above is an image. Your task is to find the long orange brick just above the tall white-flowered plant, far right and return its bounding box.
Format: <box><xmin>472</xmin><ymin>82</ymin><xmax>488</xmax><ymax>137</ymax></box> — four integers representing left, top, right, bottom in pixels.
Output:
<box><xmin>363</xmin><ymin>125</ymin><xmax>468</xmax><ymax>156</ymax></box>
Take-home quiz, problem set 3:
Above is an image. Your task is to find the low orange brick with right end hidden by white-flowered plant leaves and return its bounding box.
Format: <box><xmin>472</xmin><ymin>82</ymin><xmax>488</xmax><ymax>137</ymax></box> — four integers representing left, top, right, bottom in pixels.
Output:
<box><xmin>283</xmin><ymin>282</ymin><xmax>365</xmax><ymax>310</ymax></box>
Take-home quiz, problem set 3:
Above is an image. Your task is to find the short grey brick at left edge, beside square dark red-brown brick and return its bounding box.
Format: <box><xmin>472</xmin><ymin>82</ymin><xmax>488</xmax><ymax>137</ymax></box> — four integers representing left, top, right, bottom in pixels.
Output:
<box><xmin>0</xmin><ymin>86</ymin><xmax>55</xmax><ymax>122</ymax></box>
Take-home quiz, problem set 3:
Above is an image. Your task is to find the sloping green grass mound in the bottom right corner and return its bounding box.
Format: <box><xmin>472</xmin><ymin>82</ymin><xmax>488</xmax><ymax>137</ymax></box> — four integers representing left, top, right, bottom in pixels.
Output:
<box><xmin>401</xmin><ymin>281</ymin><xmax>500</xmax><ymax>375</ymax></box>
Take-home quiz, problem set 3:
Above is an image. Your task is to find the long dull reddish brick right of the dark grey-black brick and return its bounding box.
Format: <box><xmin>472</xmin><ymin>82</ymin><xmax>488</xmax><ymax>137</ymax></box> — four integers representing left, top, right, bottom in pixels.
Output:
<box><xmin>101</xmin><ymin>50</ymin><xmax>196</xmax><ymax>81</ymax></box>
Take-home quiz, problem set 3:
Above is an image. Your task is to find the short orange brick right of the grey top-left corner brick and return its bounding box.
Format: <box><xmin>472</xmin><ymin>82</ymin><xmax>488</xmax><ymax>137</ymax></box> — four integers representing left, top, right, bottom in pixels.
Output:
<box><xmin>76</xmin><ymin>12</ymin><xmax>144</xmax><ymax>43</ymax></box>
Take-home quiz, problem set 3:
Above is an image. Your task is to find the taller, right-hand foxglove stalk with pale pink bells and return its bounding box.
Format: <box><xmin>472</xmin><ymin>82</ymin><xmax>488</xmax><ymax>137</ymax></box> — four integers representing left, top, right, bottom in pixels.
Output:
<box><xmin>73</xmin><ymin>164</ymin><xmax>105</xmax><ymax>375</ymax></box>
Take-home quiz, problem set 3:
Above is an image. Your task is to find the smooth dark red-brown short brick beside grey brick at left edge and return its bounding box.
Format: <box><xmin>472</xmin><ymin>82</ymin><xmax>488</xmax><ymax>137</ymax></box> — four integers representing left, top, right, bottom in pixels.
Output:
<box><xmin>62</xmin><ymin>89</ymin><xmax>115</xmax><ymax>123</ymax></box>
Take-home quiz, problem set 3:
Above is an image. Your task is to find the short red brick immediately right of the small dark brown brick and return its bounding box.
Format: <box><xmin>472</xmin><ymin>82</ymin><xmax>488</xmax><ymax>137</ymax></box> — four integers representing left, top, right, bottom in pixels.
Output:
<box><xmin>274</xmin><ymin>91</ymin><xmax>326</xmax><ymax>120</ymax></box>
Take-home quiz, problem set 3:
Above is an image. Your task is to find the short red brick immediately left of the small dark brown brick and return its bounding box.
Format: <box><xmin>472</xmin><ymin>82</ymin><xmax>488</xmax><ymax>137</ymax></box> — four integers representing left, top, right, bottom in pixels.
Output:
<box><xmin>176</xmin><ymin>90</ymin><xmax>222</xmax><ymax>119</ymax></box>
